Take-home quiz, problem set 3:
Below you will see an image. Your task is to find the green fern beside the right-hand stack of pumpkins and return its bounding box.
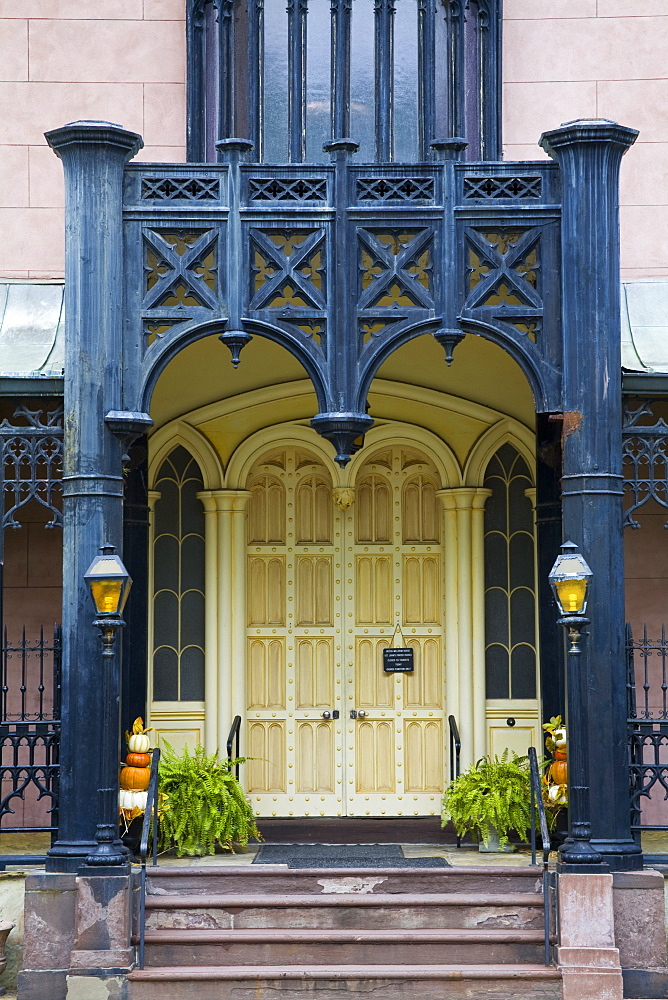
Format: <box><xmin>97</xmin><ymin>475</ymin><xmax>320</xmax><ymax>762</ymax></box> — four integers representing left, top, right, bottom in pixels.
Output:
<box><xmin>441</xmin><ymin>750</ymin><xmax>531</xmax><ymax>851</ymax></box>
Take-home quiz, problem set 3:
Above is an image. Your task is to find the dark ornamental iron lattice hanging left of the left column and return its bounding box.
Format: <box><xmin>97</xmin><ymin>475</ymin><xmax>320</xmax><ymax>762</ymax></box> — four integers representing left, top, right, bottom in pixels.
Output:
<box><xmin>0</xmin><ymin>403</ymin><xmax>63</xmax><ymax>536</ymax></box>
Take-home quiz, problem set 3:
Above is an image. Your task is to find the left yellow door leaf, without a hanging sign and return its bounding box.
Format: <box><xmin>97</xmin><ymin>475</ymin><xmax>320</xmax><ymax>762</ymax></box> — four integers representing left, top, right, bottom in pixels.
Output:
<box><xmin>246</xmin><ymin>448</ymin><xmax>343</xmax><ymax>816</ymax></box>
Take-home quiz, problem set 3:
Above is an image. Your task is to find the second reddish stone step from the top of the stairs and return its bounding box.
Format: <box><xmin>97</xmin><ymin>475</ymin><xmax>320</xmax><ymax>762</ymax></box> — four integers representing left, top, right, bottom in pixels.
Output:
<box><xmin>146</xmin><ymin>892</ymin><xmax>543</xmax><ymax>930</ymax></box>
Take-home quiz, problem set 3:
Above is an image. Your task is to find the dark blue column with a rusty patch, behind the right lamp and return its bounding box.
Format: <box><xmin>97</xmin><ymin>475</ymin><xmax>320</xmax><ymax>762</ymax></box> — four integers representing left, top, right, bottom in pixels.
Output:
<box><xmin>541</xmin><ymin>120</ymin><xmax>642</xmax><ymax>870</ymax></box>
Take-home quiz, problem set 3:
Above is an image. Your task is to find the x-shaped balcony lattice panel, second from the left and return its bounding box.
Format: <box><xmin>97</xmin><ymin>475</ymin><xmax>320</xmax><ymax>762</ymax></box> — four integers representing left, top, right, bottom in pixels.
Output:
<box><xmin>250</xmin><ymin>229</ymin><xmax>326</xmax><ymax>313</ymax></box>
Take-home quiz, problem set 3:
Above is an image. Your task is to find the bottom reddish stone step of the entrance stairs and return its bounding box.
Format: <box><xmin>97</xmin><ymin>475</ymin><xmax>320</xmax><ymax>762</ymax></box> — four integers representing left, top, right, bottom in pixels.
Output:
<box><xmin>128</xmin><ymin>964</ymin><xmax>561</xmax><ymax>1000</ymax></box>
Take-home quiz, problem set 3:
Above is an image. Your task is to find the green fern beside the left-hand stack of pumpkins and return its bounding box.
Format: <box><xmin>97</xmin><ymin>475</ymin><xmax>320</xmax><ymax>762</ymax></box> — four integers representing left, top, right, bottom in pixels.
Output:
<box><xmin>159</xmin><ymin>740</ymin><xmax>260</xmax><ymax>857</ymax></box>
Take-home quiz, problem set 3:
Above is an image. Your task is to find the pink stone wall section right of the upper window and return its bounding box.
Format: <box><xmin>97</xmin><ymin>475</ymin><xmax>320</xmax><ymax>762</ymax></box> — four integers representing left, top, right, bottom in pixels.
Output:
<box><xmin>503</xmin><ymin>0</ymin><xmax>668</xmax><ymax>281</ymax></box>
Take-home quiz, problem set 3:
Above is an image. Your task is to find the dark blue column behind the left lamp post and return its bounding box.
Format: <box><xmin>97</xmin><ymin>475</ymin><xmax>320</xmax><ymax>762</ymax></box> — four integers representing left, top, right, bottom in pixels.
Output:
<box><xmin>46</xmin><ymin>122</ymin><xmax>142</xmax><ymax>872</ymax></box>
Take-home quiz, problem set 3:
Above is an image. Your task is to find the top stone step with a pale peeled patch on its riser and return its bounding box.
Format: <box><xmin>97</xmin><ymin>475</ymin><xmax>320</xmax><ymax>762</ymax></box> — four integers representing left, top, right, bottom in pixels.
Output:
<box><xmin>147</xmin><ymin>865</ymin><xmax>542</xmax><ymax>897</ymax></box>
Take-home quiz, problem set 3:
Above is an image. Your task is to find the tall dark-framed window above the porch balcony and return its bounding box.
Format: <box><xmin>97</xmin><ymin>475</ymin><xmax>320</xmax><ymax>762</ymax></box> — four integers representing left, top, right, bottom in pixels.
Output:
<box><xmin>187</xmin><ymin>0</ymin><xmax>501</xmax><ymax>163</ymax></box>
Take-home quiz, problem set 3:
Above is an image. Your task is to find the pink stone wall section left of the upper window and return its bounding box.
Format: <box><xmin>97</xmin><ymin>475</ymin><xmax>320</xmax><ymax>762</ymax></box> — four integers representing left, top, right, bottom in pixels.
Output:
<box><xmin>0</xmin><ymin>0</ymin><xmax>185</xmax><ymax>279</ymax></box>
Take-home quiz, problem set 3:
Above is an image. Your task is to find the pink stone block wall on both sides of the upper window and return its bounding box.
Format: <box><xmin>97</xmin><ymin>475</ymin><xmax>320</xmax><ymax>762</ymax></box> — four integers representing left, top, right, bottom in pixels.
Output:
<box><xmin>0</xmin><ymin>0</ymin><xmax>668</xmax><ymax>280</ymax></box>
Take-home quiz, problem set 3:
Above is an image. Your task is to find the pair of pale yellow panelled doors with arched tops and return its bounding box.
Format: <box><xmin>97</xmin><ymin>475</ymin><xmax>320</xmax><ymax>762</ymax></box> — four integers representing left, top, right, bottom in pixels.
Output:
<box><xmin>245</xmin><ymin>446</ymin><xmax>445</xmax><ymax>816</ymax></box>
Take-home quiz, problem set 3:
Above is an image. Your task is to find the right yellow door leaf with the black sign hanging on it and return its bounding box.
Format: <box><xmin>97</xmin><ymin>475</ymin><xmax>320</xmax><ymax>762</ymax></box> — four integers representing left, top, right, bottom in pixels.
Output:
<box><xmin>346</xmin><ymin>447</ymin><xmax>445</xmax><ymax>816</ymax></box>
